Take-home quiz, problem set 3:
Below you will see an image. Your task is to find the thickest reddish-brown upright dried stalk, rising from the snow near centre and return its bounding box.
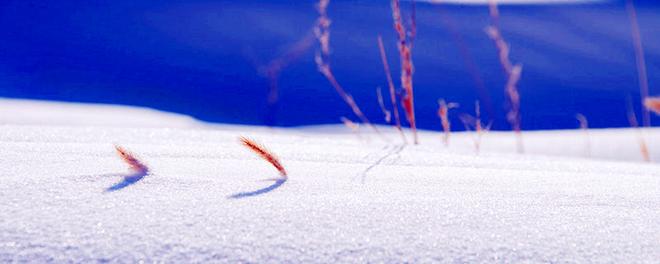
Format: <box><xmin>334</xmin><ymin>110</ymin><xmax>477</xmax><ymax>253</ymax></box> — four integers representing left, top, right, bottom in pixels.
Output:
<box><xmin>392</xmin><ymin>0</ymin><xmax>419</xmax><ymax>144</ymax></box>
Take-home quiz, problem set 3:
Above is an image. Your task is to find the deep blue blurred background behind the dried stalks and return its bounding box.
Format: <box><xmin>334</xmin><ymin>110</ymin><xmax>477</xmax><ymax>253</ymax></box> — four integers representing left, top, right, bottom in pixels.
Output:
<box><xmin>0</xmin><ymin>0</ymin><xmax>660</xmax><ymax>130</ymax></box>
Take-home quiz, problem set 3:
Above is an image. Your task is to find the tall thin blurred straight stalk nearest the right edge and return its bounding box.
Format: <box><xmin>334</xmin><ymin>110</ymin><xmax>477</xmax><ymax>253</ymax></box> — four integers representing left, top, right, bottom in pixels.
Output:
<box><xmin>626</xmin><ymin>0</ymin><xmax>651</xmax><ymax>127</ymax></box>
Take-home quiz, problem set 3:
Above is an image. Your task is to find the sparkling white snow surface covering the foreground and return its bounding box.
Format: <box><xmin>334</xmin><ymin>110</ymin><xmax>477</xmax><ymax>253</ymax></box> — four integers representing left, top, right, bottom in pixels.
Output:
<box><xmin>0</xmin><ymin>100</ymin><xmax>660</xmax><ymax>263</ymax></box>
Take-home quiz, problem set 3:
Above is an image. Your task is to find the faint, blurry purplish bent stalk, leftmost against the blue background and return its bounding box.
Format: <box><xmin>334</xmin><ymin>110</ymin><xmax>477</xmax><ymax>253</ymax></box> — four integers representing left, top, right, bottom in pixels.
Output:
<box><xmin>257</xmin><ymin>32</ymin><xmax>314</xmax><ymax>125</ymax></box>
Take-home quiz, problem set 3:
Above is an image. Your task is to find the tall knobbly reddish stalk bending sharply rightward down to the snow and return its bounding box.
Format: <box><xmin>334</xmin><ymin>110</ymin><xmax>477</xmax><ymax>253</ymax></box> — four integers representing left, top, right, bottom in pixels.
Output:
<box><xmin>314</xmin><ymin>0</ymin><xmax>380</xmax><ymax>135</ymax></box>
